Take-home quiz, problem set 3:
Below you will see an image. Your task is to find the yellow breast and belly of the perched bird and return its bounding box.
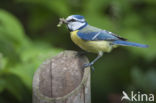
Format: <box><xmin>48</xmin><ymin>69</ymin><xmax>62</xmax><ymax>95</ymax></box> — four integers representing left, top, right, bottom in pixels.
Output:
<box><xmin>70</xmin><ymin>30</ymin><xmax>112</xmax><ymax>53</ymax></box>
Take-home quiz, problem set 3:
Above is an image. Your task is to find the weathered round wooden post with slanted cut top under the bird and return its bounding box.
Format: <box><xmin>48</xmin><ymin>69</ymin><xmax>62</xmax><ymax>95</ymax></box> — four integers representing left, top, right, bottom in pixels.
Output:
<box><xmin>33</xmin><ymin>51</ymin><xmax>91</xmax><ymax>103</ymax></box>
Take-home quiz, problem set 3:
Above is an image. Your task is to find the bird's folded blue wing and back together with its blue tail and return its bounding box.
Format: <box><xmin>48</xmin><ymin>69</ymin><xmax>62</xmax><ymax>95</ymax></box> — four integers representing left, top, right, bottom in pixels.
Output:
<box><xmin>77</xmin><ymin>26</ymin><xmax>148</xmax><ymax>48</ymax></box>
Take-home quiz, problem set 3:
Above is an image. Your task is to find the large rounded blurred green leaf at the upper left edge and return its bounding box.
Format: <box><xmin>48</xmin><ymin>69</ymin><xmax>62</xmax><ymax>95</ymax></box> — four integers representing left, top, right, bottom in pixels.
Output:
<box><xmin>0</xmin><ymin>9</ymin><xmax>27</xmax><ymax>46</ymax></box>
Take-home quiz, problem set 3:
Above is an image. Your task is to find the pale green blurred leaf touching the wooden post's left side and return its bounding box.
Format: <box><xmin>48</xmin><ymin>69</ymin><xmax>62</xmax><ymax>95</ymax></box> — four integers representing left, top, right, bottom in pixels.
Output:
<box><xmin>8</xmin><ymin>43</ymin><xmax>61</xmax><ymax>88</ymax></box>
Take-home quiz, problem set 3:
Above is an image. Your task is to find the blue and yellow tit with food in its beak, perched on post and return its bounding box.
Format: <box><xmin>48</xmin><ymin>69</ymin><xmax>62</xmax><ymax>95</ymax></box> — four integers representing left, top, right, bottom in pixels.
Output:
<box><xmin>58</xmin><ymin>15</ymin><xmax>148</xmax><ymax>68</ymax></box>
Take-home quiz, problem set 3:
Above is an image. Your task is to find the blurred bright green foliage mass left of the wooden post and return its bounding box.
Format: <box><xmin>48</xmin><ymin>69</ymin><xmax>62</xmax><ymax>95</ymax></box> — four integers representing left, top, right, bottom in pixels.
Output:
<box><xmin>0</xmin><ymin>10</ymin><xmax>60</xmax><ymax>102</ymax></box>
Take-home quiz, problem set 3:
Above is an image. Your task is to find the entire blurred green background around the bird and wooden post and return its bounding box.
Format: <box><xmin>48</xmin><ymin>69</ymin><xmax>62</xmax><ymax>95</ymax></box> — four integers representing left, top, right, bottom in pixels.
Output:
<box><xmin>0</xmin><ymin>0</ymin><xmax>156</xmax><ymax>103</ymax></box>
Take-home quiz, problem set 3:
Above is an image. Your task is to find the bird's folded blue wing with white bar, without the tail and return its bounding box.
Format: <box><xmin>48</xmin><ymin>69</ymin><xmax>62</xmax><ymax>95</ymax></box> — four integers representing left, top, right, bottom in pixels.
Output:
<box><xmin>77</xmin><ymin>26</ymin><xmax>126</xmax><ymax>41</ymax></box>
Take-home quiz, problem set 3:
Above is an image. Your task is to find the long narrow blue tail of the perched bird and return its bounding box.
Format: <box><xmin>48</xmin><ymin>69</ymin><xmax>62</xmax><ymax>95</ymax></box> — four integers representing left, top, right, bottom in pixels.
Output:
<box><xmin>113</xmin><ymin>40</ymin><xmax>148</xmax><ymax>48</ymax></box>
